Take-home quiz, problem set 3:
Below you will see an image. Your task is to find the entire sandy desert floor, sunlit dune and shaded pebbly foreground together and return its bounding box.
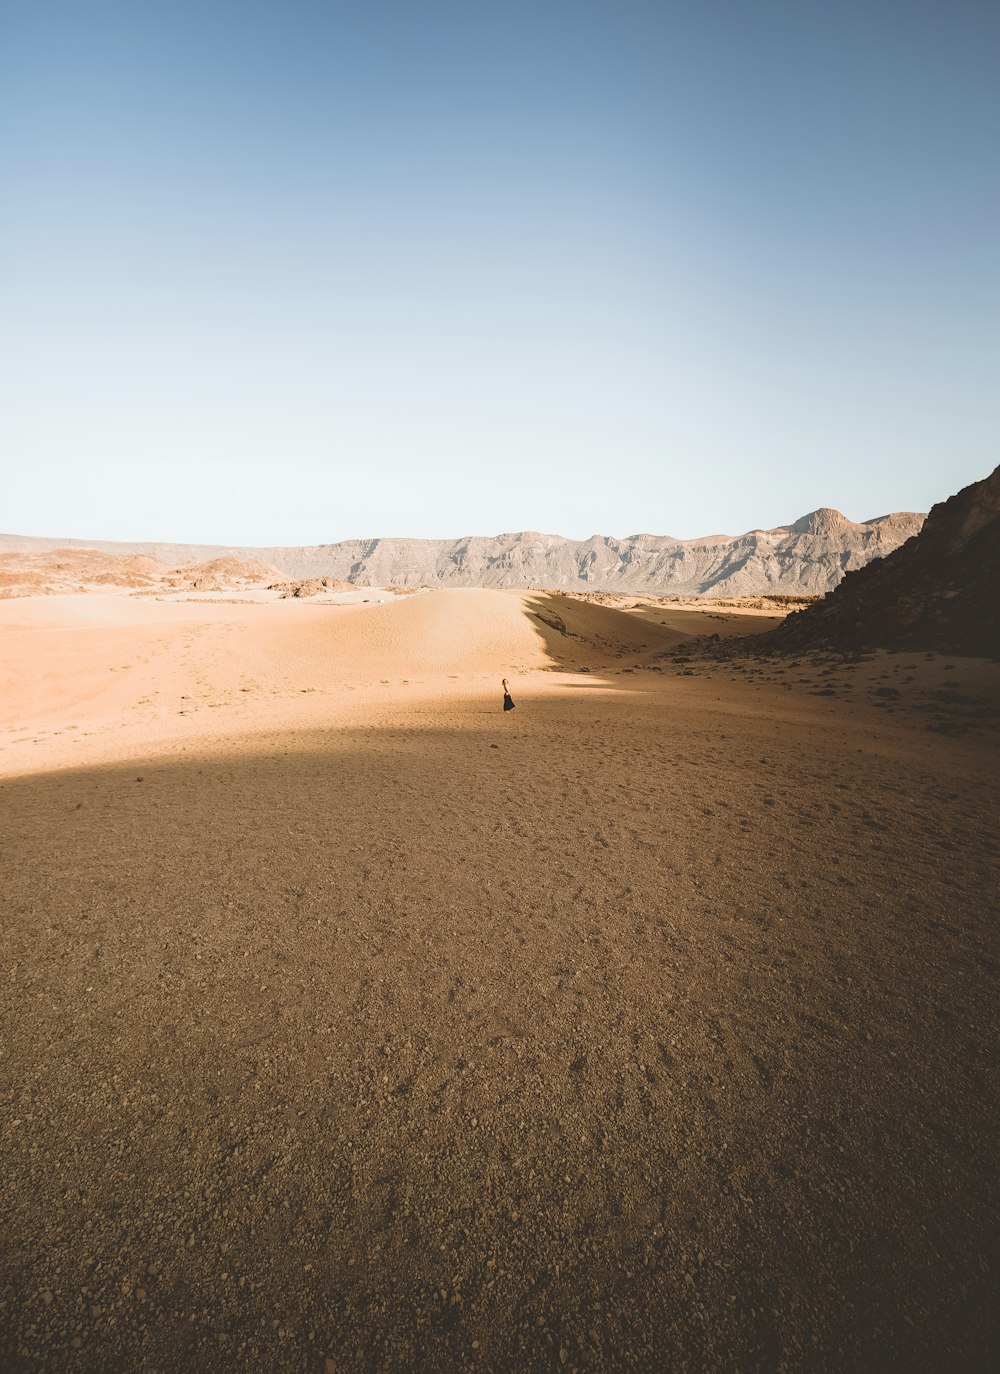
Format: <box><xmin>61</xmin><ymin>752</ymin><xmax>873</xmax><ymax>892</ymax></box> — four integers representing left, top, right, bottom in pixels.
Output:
<box><xmin>0</xmin><ymin>588</ymin><xmax>1000</xmax><ymax>1374</ymax></box>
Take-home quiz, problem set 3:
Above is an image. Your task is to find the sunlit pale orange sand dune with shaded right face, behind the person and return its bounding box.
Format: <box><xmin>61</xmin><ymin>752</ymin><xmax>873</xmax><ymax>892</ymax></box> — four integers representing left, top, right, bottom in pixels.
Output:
<box><xmin>0</xmin><ymin>589</ymin><xmax>683</xmax><ymax>771</ymax></box>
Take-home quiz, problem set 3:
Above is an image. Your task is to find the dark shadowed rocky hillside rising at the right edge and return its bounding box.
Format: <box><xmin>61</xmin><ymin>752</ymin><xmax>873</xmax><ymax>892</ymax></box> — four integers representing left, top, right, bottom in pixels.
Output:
<box><xmin>771</xmin><ymin>467</ymin><xmax>1000</xmax><ymax>658</ymax></box>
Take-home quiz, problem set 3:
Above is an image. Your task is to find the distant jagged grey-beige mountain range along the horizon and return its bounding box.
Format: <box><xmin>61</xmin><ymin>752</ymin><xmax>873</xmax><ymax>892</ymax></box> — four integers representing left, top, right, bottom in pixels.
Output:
<box><xmin>0</xmin><ymin>507</ymin><xmax>924</xmax><ymax>596</ymax></box>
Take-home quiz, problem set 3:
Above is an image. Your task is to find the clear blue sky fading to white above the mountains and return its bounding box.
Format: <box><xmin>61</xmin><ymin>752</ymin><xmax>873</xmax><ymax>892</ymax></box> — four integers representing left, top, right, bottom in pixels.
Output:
<box><xmin>0</xmin><ymin>0</ymin><xmax>1000</xmax><ymax>544</ymax></box>
